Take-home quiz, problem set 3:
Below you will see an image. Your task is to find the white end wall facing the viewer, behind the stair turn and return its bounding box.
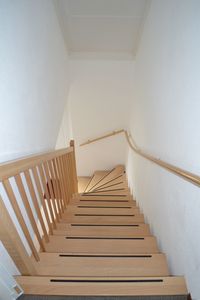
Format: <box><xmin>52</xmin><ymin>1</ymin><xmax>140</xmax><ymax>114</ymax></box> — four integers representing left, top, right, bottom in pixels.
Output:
<box><xmin>56</xmin><ymin>59</ymin><xmax>134</xmax><ymax>175</ymax></box>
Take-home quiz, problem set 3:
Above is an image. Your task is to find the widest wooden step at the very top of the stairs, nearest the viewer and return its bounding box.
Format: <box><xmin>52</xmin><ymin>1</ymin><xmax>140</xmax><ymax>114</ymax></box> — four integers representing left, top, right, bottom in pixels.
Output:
<box><xmin>15</xmin><ymin>276</ymin><xmax>187</xmax><ymax>296</ymax></box>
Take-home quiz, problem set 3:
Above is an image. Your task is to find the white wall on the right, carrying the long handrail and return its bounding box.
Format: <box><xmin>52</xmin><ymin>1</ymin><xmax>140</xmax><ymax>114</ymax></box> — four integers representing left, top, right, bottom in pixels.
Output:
<box><xmin>127</xmin><ymin>0</ymin><xmax>200</xmax><ymax>299</ymax></box>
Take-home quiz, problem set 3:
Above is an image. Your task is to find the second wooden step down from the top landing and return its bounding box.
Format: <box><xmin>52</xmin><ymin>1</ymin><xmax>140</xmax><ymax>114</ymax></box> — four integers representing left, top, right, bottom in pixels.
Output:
<box><xmin>32</xmin><ymin>253</ymin><xmax>169</xmax><ymax>277</ymax></box>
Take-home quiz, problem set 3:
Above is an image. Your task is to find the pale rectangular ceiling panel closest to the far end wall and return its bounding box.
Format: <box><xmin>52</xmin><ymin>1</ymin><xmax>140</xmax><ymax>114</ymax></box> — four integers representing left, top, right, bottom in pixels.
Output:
<box><xmin>70</xmin><ymin>17</ymin><xmax>140</xmax><ymax>52</ymax></box>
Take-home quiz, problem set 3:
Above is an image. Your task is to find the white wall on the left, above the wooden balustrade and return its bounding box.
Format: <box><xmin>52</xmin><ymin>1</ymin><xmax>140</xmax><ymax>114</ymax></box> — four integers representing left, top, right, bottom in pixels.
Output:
<box><xmin>0</xmin><ymin>0</ymin><xmax>69</xmax><ymax>299</ymax></box>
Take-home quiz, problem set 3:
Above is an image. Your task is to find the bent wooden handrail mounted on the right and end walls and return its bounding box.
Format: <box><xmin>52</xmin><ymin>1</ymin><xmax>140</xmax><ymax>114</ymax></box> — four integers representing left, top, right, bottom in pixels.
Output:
<box><xmin>80</xmin><ymin>129</ymin><xmax>200</xmax><ymax>186</ymax></box>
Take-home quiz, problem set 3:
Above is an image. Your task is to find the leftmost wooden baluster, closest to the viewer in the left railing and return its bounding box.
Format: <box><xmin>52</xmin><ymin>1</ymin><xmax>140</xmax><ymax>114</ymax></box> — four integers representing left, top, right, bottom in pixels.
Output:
<box><xmin>2</xmin><ymin>179</ymin><xmax>40</xmax><ymax>261</ymax></box>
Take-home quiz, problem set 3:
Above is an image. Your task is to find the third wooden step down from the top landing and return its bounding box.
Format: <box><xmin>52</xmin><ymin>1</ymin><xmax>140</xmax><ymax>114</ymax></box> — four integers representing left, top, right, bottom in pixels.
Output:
<box><xmin>45</xmin><ymin>235</ymin><xmax>159</xmax><ymax>254</ymax></box>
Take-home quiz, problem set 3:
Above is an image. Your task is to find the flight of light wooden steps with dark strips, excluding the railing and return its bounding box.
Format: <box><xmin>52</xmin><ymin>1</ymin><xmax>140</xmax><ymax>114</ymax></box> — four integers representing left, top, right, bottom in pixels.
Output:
<box><xmin>16</xmin><ymin>166</ymin><xmax>187</xmax><ymax>296</ymax></box>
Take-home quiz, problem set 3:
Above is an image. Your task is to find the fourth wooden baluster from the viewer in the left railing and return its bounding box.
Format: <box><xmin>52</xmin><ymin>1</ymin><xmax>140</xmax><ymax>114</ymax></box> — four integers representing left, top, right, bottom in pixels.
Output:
<box><xmin>31</xmin><ymin>167</ymin><xmax>53</xmax><ymax>234</ymax></box>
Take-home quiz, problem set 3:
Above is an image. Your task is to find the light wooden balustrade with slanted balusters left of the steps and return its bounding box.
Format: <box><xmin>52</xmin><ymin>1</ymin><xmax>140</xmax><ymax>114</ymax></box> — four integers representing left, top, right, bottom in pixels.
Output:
<box><xmin>0</xmin><ymin>141</ymin><xmax>78</xmax><ymax>275</ymax></box>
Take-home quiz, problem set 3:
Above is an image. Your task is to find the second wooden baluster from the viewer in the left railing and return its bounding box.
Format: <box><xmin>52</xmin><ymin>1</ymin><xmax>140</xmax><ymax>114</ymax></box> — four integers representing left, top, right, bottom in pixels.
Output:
<box><xmin>15</xmin><ymin>174</ymin><xmax>45</xmax><ymax>251</ymax></box>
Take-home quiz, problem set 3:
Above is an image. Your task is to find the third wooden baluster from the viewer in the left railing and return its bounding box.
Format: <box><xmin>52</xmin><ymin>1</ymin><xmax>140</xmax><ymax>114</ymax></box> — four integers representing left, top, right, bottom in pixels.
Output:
<box><xmin>24</xmin><ymin>170</ymin><xmax>49</xmax><ymax>242</ymax></box>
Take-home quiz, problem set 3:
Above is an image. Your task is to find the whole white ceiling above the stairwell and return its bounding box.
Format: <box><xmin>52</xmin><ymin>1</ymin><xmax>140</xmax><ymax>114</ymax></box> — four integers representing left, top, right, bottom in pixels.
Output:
<box><xmin>57</xmin><ymin>0</ymin><xmax>150</xmax><ymax>58</ymax></box>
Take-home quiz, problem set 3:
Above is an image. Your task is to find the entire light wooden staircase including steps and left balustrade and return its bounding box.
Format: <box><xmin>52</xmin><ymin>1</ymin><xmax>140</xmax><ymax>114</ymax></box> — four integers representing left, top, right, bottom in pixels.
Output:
<box><xmin>0</xmin><ymin>145</ymin><xmax>188</xmax><ymax>300</ymax></box>
